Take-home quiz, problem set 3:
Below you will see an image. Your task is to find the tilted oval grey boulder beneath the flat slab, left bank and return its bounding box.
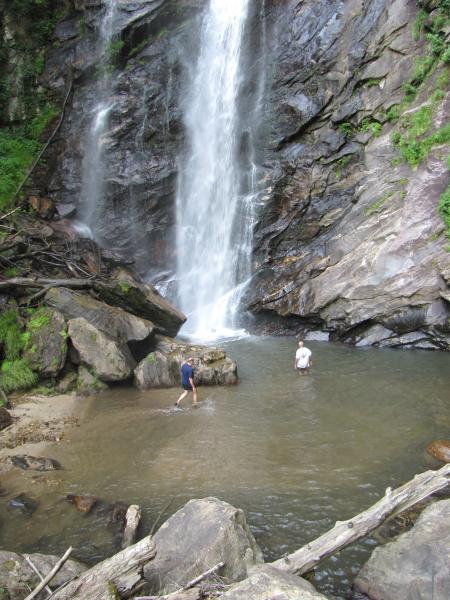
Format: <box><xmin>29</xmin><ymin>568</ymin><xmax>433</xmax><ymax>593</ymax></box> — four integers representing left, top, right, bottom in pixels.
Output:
<box><xmin>69</xmin><ymin>318</ymin><xmax>136</xmax><ymax>381</ymax></box>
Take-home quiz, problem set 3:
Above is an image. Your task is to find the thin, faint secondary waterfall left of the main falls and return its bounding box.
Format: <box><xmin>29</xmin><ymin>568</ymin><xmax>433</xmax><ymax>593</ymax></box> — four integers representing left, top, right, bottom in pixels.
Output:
<box><xmin>75</xmin><ymin>0</ymin><xmax>118</xmax><ymax>239</ymax></box>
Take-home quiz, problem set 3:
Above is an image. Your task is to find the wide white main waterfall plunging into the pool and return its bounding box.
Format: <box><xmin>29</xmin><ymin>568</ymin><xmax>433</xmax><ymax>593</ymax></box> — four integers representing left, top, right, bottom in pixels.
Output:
<box><xmin>177</xmin><ymin>0</ymin><xmax>255</xmax><ymax>339</ymax></box>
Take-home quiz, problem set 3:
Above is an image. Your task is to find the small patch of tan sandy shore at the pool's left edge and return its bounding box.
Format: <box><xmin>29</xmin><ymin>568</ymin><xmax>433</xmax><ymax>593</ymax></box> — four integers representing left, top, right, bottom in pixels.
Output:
<box><xmin>0</xmin><ymin>394</ymin><xmax>83</xmax><ymax>472</ymax></box>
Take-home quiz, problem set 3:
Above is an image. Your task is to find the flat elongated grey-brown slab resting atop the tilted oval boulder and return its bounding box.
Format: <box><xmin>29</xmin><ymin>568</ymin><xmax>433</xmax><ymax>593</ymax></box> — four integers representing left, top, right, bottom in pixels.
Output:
<box><xmin>45</xmin><ymin>288</ymin><xmax>155</xmax><ymax>343</ymax></box>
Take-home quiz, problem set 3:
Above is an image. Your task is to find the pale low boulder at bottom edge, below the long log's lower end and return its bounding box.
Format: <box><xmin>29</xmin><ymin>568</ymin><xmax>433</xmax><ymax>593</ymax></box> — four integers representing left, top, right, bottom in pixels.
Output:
<box><xmin>221</xmin><ymin>565</ymin><xmax>326</xmax><ymax>600</ymax></box>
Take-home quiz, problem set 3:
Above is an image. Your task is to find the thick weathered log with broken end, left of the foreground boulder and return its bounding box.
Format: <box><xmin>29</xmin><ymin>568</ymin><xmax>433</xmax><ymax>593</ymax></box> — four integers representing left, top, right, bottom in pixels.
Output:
<box><xmin>52</xmin><ymin>536</ymin><xmax>156</xmax><ymax>600</ymax></box>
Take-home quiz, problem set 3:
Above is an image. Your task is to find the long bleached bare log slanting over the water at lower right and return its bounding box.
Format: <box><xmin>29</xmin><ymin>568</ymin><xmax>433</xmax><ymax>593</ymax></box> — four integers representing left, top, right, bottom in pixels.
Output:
<box><xmin>271</xmin><ymin>464</ymin><xmax>450</xmax><ymax>575</ymax></box>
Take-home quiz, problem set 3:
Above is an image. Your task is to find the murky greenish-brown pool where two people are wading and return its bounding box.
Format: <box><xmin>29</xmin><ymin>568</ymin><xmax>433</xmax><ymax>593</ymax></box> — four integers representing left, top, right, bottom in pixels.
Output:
<box><xmin>0</xmin><ymin>337</ymin><xmax>450</xmax><ymax>599</ymax></box>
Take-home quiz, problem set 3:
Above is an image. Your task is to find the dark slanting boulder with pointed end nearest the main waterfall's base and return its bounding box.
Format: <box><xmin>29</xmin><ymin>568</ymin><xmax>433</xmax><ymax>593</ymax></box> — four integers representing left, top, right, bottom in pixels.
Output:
<box><xmin>94</xmin><ymin>278</ymin><xmax>186</xmax><ymax>336</ymax></box>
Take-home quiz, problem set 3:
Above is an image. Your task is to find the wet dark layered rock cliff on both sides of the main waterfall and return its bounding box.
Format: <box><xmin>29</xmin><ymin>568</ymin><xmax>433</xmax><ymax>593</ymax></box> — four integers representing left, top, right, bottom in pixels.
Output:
<box><xmin>7</xmin><ymin>0</ymin><xmax>450</xmax><ymax>349</ymax></box>
